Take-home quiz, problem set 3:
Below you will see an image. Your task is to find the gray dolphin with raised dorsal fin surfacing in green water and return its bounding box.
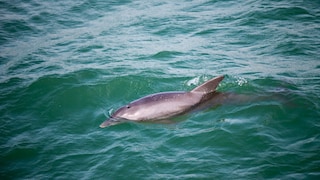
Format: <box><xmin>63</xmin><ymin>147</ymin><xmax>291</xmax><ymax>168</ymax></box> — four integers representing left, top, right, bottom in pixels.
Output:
<box><xmin>100</xmin><ymin>76</ymin><xmax>225</xmax><ymax>128</ymax></box>
